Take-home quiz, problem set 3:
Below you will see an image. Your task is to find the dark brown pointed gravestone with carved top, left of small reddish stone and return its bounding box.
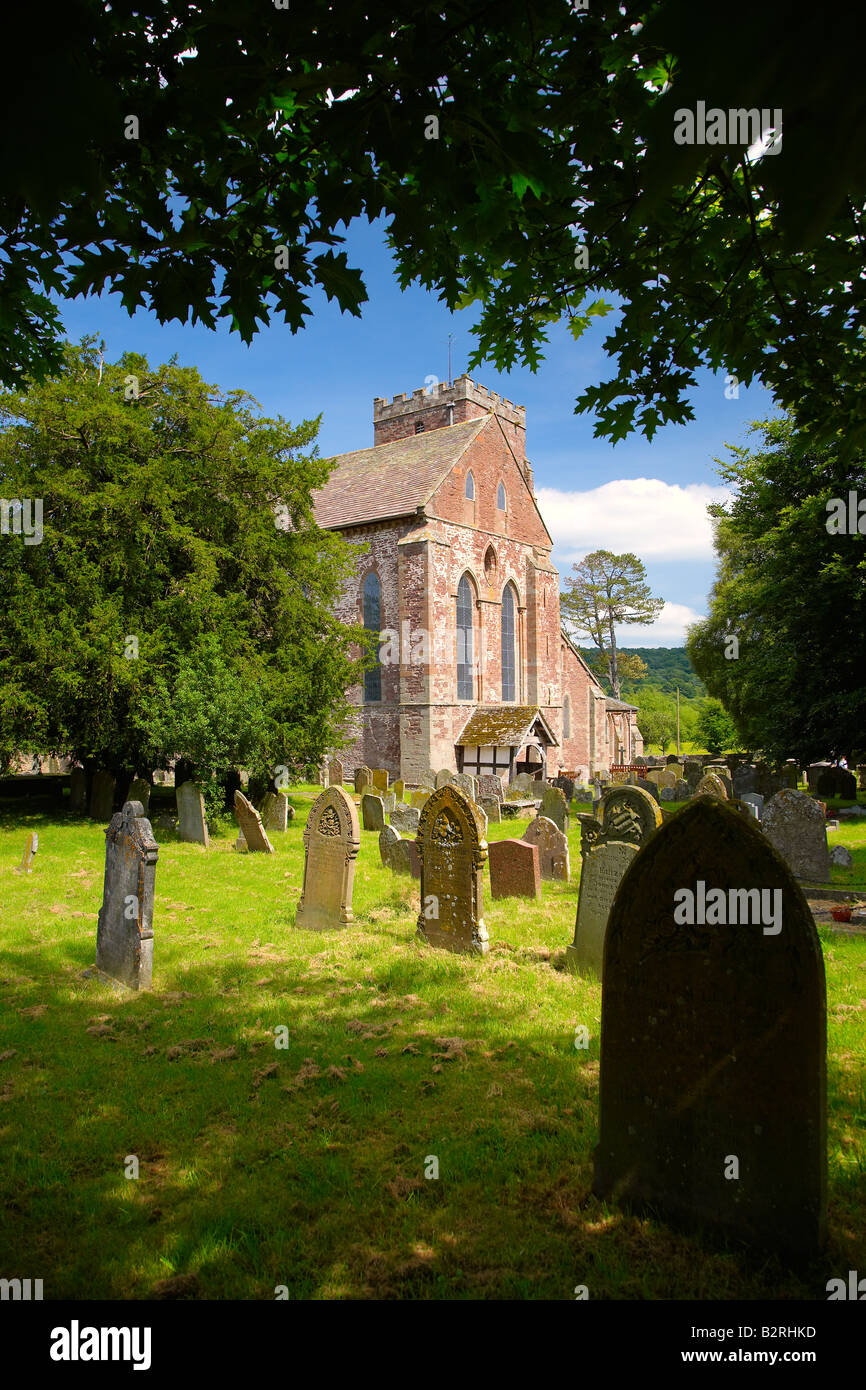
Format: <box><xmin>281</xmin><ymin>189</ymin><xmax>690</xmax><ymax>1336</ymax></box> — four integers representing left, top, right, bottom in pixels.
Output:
<box><xmin>416</xmin><ymin>787</ymin><xmax>489</xmax><ymax>955</ymax></box>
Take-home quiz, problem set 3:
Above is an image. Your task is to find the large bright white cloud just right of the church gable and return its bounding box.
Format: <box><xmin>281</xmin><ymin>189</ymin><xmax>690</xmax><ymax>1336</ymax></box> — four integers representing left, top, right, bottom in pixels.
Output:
<box><xmin>538</xmin><ymin>478</ymin><xmax>731</xmax><ymax>563</ymax></box>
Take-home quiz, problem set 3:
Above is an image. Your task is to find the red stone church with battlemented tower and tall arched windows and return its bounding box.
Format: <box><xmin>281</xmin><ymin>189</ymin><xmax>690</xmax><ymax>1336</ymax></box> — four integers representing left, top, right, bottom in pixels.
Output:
<box><xmin>314</xmin><ymin>375</ymin><xmax>644</xmax><ymax>783</ymax></box>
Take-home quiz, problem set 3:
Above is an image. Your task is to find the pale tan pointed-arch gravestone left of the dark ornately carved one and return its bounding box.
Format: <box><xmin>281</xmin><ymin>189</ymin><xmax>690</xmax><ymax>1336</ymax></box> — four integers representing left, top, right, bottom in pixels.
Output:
<box><xmin>295</xmin><ymin>787</ymin><xmax>361</xmax><ymax>931</ymax></box>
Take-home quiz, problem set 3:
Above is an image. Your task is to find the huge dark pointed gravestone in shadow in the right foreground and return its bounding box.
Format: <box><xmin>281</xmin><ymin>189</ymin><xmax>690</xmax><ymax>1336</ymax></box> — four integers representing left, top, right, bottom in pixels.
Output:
<box><xmin>594</xmin><ymin>799</ymin><xmax>827</xmax><ymax>1255</ymax></box>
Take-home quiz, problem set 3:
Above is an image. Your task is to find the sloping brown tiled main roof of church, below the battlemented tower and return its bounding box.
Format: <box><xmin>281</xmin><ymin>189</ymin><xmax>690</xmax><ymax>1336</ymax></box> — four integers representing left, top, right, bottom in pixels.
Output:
<box><xmin>313</xmin><ymin>416</ymin><xmax>493</xmax><ymax>528</ymax></box>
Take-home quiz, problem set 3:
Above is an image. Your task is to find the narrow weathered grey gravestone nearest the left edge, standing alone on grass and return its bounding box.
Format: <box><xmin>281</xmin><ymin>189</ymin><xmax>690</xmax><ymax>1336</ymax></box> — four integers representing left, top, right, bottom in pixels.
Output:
<box><xmin>96</xmin><ymin>801</ymin><xmax>160</xmax><ymax>990</ymax></box>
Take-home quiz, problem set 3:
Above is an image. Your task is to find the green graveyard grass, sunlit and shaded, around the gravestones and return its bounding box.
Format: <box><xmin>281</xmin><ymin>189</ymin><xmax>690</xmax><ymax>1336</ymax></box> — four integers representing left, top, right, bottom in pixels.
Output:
<box><xmin>0</xmin><ymin>787</ymin><xmax>866</xmax><ymax>1300</ymax></box>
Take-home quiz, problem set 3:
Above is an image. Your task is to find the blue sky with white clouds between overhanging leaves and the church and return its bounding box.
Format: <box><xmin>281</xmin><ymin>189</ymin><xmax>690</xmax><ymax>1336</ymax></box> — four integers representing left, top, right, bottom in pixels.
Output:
<box><xmin>52</xmin><ymin>222</ymin><xmax>773</xmax><ymax>646</ymax></box>
